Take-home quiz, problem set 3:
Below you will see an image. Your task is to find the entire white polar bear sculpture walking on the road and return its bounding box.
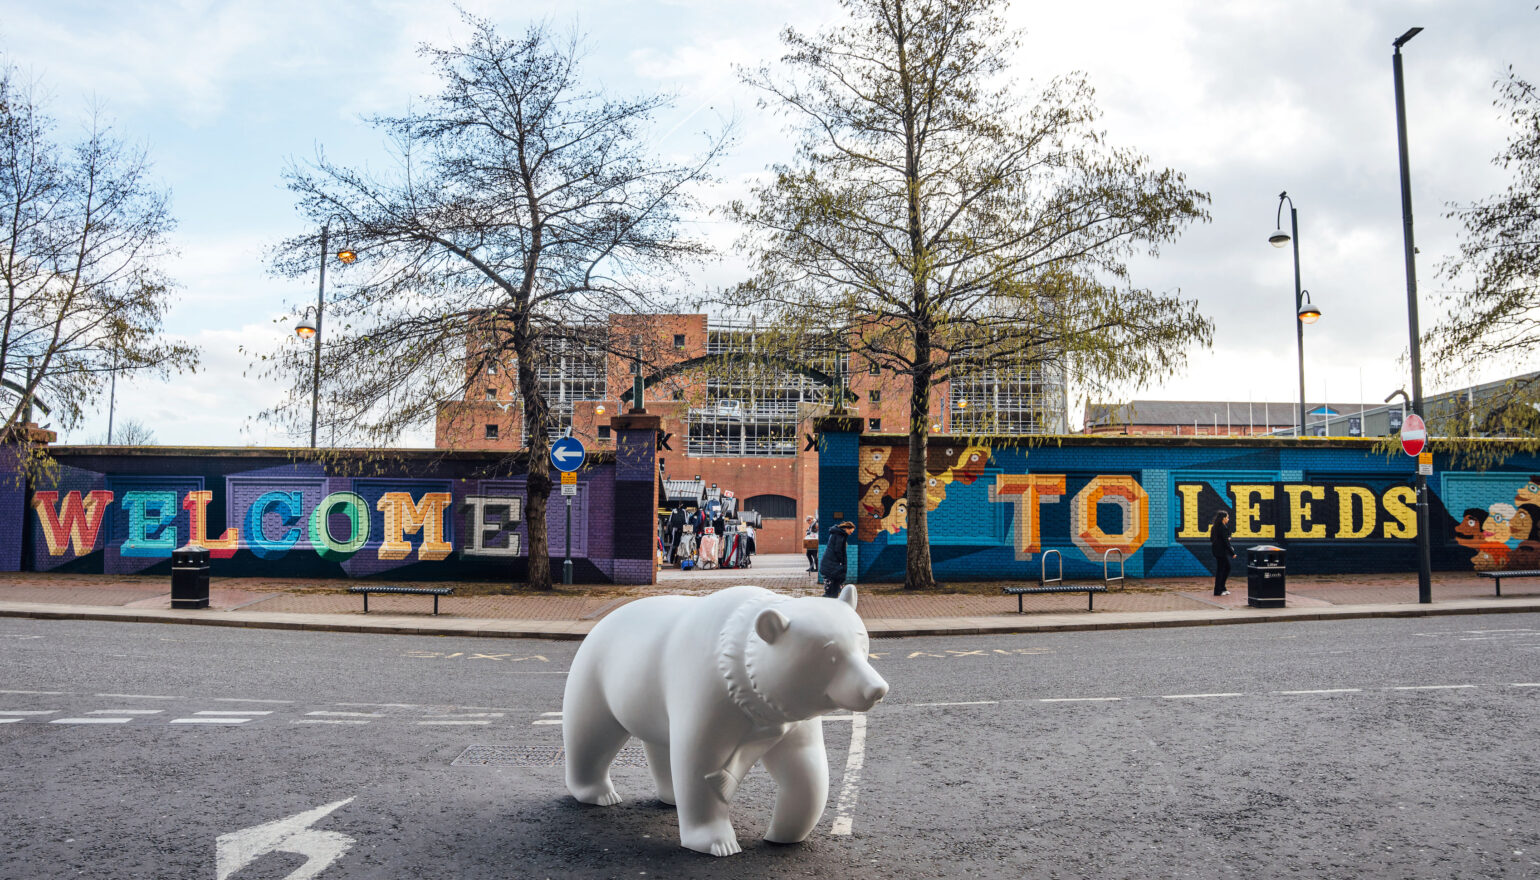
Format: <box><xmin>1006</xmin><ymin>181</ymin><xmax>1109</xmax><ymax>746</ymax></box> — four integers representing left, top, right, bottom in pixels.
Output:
<box><xmin>562</xmin><ymin>586</ymin><xmax>887</xmax><ymax>855</ymax></box>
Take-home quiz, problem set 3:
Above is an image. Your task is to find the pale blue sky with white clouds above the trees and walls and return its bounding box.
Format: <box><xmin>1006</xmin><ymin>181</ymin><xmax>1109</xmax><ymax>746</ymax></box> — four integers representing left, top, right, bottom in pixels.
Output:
<box><xmin>0</xmin><ymin>0</ymin><xmax>1540</xmax><ymax>445</ymax></box>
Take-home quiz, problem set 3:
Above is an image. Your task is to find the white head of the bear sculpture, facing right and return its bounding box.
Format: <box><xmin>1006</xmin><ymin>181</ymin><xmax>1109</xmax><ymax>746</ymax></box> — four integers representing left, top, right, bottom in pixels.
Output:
<box><xmin>748</xmin><ymin>586</ymin><xmax>887</xmax><ymax>718</ymax></box>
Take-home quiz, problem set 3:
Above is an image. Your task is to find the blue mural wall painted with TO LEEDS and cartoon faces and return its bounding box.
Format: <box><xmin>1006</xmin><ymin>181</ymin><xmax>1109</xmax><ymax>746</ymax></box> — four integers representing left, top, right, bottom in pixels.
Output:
<box><xmin>819</xmin><ymin>422</ymin><xmax>1540</xmax><ymax>581</ymax></box>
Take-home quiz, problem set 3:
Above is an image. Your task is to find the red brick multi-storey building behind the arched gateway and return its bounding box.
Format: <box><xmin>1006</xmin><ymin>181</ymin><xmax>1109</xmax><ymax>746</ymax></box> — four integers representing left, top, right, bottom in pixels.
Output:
<box><xmin>436</xmin><ymin>314</ymin><xmax>1064</xmax><ymax>553</ymax></box>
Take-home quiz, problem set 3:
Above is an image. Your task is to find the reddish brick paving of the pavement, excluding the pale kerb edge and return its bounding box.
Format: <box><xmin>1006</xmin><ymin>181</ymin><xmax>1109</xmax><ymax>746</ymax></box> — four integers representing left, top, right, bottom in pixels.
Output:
<box><xmin>0</xmin><ymin>569</ymin><xmax>1540</xmax><ymax>621</ymax></box>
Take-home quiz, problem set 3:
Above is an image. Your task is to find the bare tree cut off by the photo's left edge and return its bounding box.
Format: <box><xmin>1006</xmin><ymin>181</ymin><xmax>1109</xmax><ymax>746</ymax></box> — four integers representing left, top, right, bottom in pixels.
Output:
<box><xmin>0</xmin><ymin>68</ymin><xmax>199</xmax><ymax>453</ymax></box>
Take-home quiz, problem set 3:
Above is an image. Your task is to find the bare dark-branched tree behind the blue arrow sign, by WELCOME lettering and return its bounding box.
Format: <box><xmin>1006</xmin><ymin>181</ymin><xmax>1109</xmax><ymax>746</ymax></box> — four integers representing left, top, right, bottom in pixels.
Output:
<box><xmin>268</xmin><ymin>12</ymin><xmax>722</xmax><ymax>589</ymax></box>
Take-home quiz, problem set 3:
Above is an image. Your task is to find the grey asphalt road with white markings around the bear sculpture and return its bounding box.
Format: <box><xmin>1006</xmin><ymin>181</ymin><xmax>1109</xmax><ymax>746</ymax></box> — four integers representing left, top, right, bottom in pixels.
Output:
<box><xmin>0</xmin><ymin>615</ymin><xmax>1540</xmax><ymax>880</ymax></box>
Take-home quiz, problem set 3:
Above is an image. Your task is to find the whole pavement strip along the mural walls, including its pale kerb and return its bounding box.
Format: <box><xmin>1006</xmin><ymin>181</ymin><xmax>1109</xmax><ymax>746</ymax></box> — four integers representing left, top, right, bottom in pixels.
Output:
<box><xmin>0</xmin><ymin>555</ymin><xmax>1540</xmax><ymax>640</ymax></box>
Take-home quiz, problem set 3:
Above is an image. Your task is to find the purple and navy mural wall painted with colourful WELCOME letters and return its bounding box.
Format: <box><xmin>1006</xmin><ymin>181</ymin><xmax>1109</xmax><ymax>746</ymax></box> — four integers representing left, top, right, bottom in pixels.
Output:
<box><xmin>10</xmin><ymin>443</ymin><xmax>651</xmax><ymax>583</ymax></box>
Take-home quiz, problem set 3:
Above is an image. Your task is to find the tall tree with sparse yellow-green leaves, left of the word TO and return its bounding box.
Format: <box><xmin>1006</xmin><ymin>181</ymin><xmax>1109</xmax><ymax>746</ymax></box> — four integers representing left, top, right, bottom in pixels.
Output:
<box><xmin>733</xmin><ymin>0</ymin><xmax>1212</xmax><ymax>589</ymax></box>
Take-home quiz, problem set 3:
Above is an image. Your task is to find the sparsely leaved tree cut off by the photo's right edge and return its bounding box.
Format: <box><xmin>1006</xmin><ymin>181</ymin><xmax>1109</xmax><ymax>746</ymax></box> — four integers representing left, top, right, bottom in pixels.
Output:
<box><xmin>1425</xmin><ymin>68</ymin><xmax>1540</xmax><ymax>453</ymax></box>
